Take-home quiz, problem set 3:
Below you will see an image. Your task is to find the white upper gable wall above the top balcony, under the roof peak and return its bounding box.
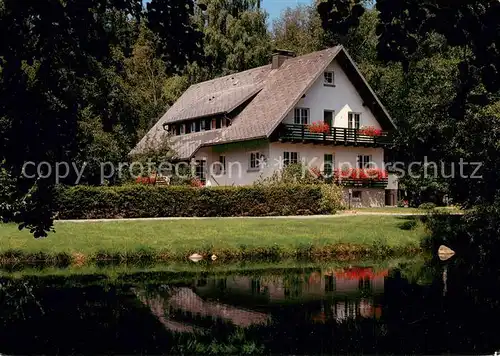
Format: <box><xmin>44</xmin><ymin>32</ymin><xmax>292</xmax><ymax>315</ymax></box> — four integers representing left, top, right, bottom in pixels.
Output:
<box><xmin>283</xmin><ymin>60</ymin><xmax>381</xmax><ymax>129</ymax></box>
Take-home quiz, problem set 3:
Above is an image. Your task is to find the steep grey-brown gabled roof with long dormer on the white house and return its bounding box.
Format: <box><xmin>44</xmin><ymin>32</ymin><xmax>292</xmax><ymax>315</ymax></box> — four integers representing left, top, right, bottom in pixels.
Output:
<box><xmin>131</xmin><ymin>46</ymin><xmax>395</xmax><ymax>159</ymax></box>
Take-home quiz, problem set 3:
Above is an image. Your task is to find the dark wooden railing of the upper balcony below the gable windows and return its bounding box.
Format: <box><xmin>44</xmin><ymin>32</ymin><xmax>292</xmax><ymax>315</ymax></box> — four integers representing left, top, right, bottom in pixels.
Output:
<box><xmin>278</xmin><ymin>124</ymin><xmax>392</xmax><ymax>147</ymax></box>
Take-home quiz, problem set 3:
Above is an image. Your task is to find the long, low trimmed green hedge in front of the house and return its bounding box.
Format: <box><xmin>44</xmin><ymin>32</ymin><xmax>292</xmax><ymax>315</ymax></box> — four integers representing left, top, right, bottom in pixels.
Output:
<box><xmin>57</xmin><ymin>185</ymin><xmax>338</xmax><ymax>219</ymax></box>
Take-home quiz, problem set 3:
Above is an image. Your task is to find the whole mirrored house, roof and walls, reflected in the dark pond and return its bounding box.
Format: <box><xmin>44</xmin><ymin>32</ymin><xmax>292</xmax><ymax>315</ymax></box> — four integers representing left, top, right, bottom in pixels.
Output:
<box><xmin>136</xmin><ymin>268</ymin><xmax>387</xmax><ymax>332</ymax></box>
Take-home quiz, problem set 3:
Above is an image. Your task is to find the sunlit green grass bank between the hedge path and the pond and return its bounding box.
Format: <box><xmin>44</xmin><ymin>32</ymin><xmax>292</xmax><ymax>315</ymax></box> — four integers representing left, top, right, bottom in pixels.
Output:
<box><xmin>0</xmin><ymin>216</ymin><xmax>426</xmax><ymax>265</ymax></box>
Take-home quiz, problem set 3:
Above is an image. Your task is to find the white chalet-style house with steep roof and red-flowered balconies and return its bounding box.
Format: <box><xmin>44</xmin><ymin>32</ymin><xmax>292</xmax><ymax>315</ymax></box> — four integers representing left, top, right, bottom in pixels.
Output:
<box><xmin>131</xmin><ymin>46</ymin><xmax>397</xmax><ymax>206</ymax></box>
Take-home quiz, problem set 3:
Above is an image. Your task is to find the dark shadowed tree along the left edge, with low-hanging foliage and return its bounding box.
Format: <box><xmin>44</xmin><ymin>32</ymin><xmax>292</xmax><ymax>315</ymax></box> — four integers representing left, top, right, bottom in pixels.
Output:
<box><xmin>0</xmin><ymin>0</ymin><xmax>140</xmax><ymax>237</ymax></box>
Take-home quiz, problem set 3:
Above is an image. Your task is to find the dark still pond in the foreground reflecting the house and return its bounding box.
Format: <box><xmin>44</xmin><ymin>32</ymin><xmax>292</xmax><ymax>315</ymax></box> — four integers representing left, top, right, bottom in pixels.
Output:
<box><xmin>0</xmin><ymin>259</ymin><xmax>500</xmax><ymax>355</ymax></box>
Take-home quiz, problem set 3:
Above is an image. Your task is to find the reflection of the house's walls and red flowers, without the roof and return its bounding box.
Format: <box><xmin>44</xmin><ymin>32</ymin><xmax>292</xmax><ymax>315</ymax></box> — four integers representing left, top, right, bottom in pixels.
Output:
<box><xmin>195</xmin><ymin>268</ymin><xmax>388</xmax><ymax>321</ymax></box>
